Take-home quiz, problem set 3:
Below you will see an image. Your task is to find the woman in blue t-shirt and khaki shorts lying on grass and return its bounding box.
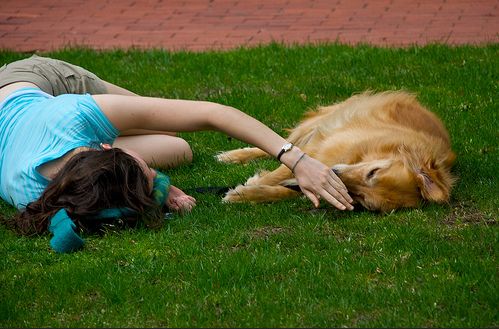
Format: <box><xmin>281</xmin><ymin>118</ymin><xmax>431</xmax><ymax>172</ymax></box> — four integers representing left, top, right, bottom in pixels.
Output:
<box><xmin>0</xmin><ymin>56</ymin><xmax>352</xmax><ymax>252</ymax></box>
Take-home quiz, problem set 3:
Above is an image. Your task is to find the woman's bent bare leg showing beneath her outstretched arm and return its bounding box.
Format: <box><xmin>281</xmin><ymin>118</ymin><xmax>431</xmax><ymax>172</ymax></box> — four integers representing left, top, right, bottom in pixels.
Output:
<box><xmin>113</xmin><ymin>135</ymin><xmax>192</xmax><ymax>169</ymax></box>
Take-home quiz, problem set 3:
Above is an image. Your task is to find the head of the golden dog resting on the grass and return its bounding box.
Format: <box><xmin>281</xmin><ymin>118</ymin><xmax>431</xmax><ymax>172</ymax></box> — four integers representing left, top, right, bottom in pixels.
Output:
<box><xmin>333</xmin><ymin>145</ymin><xmax>455</xmax><ymax>212</ymax></box>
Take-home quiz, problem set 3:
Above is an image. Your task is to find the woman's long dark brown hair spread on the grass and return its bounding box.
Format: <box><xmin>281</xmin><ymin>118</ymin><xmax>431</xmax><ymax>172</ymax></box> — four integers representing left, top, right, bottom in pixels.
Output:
<box><xmin>9</xmin><ymin>148</ymin><xmax>162</xmax><ymax>235</ymax></box>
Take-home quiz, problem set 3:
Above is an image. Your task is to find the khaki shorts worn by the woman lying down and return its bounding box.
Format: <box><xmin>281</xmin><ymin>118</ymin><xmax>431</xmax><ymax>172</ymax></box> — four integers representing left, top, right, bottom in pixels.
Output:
<box><xmin>0</xmin><ymin>55</ymin><xmax>107</xmax><ymax>96</ymax></box>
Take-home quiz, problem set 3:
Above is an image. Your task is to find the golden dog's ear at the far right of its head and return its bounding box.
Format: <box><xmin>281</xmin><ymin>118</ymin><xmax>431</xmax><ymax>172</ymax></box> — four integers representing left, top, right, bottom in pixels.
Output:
<box><xmin>416</xmin><ymin>167</ymin><xmax>450</xmax><ymax>203</ymax></box>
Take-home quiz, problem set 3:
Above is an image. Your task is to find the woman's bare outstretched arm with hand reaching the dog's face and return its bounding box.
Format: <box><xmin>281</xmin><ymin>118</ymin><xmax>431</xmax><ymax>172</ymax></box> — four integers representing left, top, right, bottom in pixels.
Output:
<box><xmin>93</xmin><ymin>95</ymin><xmax>353</xmax><ymax>210</ymax></box>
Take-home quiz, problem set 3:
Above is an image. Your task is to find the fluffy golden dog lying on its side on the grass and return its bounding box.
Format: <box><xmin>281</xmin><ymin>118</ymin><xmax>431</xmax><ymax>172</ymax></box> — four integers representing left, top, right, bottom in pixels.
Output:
<box><xmin>216</xmin><ymin>91</ymin><xmax>456</xmax><ymax>212</ymax></box>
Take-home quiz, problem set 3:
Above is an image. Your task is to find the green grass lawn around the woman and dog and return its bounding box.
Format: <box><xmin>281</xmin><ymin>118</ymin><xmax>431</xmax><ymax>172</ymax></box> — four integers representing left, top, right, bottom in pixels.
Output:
<box><xmin>0</xmin><ymin>44</ymin><xmax>499</xmax><ymax>327</ymax></box>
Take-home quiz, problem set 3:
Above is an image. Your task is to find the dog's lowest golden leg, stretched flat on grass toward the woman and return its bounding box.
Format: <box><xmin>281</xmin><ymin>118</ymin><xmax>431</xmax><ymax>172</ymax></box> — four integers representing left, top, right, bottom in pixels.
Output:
<box><xmin>223</xmin><ymin>185</ymin><xmax>299</xmax><ymax>202</ymax></box>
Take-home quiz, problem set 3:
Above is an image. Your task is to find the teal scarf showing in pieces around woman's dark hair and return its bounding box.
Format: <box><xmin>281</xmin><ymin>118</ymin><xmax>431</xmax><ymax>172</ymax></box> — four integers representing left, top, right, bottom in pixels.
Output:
<box><xmin>49</xmin><ymin>172</ymin><xmax>170</xmax><ymax>253</ymax></box>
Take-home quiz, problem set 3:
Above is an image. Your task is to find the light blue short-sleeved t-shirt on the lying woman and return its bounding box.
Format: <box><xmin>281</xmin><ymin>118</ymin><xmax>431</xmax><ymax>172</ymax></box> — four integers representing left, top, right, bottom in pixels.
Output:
<box><xmin>0</xmin><ymin>88</ymin><xmax>119</xmax><ymax>208</ymax></box>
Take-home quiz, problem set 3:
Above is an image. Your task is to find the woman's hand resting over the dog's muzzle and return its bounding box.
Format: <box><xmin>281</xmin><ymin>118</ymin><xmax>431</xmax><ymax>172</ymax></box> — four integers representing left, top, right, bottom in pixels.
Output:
<box><xmin>294</xmin><ymin>156</ymin><xmax>353</xmax><ymax>210</ymax></box>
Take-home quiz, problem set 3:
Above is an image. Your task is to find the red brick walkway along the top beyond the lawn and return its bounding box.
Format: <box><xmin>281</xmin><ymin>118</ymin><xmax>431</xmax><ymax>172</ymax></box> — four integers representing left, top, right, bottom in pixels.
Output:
<box><xmin>0</xmin><ymin>0</ymin><xmax>499</xmax><ymax>52</ymax></box>
